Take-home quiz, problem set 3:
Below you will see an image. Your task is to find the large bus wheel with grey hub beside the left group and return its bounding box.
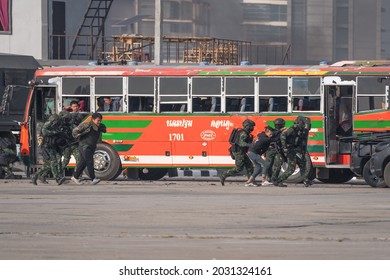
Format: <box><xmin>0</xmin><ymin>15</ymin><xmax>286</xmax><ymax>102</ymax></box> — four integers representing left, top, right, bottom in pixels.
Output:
<box><xmin>84</xmin><ymin>143</ymin><xmax>122</xmax><ymax>181</ymax></box>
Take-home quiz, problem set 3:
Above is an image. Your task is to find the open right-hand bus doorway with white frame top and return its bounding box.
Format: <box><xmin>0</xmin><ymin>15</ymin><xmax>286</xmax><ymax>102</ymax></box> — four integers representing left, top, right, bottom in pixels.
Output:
<box><xmin>323</xmin><ymin>77</ymin><xmax>355</xmax><ymax>165</ymax></box>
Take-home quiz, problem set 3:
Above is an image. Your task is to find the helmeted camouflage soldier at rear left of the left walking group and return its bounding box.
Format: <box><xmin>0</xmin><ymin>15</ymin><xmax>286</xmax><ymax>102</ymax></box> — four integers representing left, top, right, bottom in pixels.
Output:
<box><xmin>32</xmin><ymin>114</ymin><xmax>65</xmax><ymax>185</ymax></box>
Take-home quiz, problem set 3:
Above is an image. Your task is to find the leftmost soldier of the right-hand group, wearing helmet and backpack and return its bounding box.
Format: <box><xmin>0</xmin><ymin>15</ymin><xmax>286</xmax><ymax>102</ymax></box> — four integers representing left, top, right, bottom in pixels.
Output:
<box><xmin>220</xmin><ymin>120</ymin><xmax>256</xmax><ymax>186</ymax></box>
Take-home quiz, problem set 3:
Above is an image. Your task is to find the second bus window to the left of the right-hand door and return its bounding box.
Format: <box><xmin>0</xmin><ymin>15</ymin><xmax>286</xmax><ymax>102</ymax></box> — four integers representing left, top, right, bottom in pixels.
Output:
<box><xmin>259</xmin><ymin>77</ymin><xmax>288</xmax><ymax>112</ymax></box>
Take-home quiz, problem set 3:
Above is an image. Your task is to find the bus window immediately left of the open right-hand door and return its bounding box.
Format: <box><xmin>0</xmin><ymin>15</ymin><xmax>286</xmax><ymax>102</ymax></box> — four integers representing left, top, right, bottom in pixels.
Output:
<box><xmin>292</xmin><ymin>77</ymin><xmax>321</xmax><ymax>112</ymax></box>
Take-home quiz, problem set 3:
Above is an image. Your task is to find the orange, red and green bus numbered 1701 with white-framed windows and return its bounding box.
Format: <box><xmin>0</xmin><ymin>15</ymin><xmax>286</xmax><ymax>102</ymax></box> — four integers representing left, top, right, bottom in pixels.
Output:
<box><xmin>20</xmin><ymin>61</ymin><xmax>390</xmax><ymax>183</ymax></box>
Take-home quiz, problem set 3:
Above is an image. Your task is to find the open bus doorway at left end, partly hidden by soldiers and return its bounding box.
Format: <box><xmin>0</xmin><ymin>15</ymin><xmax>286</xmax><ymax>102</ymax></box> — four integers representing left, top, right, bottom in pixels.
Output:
<box><xmin>28</xmin><ymin>86</ymin><xmax>58</xmax><ymax>165</ymax></box>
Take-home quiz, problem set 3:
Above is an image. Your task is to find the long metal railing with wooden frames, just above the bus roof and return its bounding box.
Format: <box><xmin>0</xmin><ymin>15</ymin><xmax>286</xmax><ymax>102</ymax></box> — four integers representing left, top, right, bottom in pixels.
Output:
<box><xmin>48</xmin><ymin>35</ymin><xmax>290</xmax><ymax>65</ymax></box>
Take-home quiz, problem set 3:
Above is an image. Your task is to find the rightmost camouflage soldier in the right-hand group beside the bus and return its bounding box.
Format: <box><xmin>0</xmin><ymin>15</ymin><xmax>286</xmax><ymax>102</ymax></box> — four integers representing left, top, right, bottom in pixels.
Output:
<box><xmin>274</xmin><ymin>117</ymin><xmax>312</xmax><ymax>187</ymax></box>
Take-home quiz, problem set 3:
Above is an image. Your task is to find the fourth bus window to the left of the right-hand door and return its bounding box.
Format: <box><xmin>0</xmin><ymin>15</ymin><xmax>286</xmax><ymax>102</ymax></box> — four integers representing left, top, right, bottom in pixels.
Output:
<box><xmin>191</xmin><ymin>77</ymin><xmax>221</xmax><ymax>112</ymax></box>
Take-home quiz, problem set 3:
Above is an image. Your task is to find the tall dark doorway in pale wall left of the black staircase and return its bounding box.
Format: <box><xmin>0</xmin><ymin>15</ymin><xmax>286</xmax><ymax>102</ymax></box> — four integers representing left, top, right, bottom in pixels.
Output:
<box><xmin>52</xmin><ymin>1</ymin><xmax>66</xmax><ymax>59</ymax></box>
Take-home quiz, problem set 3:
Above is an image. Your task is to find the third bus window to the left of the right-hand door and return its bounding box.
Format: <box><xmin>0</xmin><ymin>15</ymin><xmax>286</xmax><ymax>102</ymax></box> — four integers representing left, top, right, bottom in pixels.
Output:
<box><xmin>225</xmin><ymin>77</ymin><xmax>255</xmax><ymax>112</ymax></box>
